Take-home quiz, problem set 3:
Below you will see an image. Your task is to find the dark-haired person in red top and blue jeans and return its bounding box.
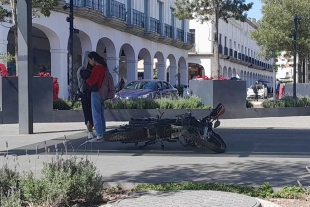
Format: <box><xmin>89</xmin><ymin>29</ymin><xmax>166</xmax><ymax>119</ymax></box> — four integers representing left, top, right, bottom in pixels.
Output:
<box><xmin>86</xmin><ymin>52</ymin><xmax>107</xmax><ymax>140</ymax></box>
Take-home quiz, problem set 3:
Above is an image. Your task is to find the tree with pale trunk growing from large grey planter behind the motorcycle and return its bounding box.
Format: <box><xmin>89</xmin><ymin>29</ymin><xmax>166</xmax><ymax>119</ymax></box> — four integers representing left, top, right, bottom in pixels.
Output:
<box><xmin>174</xmin><ymin>0</ymin><xmax>253</xmax><ymax>79</ymax></box>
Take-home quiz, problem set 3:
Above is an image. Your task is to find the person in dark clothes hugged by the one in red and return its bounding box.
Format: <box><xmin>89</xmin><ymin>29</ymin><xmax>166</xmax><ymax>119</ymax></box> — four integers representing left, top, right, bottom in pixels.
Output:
<box><xmin>77</xmin><ymin>51</ymin><xmax>94</xmax><ymax>139</ymax></box>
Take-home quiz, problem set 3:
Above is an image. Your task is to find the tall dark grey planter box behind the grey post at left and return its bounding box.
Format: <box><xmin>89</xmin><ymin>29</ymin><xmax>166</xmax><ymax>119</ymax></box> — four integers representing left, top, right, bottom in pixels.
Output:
<box><xmin>0</xmin><ymin>77</ymin><xmax>53</xmax><ymax>124</ymax></box>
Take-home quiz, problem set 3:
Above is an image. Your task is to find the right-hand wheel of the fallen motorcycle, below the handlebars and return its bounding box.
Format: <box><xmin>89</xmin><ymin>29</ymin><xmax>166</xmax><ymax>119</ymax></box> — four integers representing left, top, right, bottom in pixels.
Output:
<box><xmin>183</xmin><ymin>127</ymin><xmax>226</xmax><ymax>153</ymax></box>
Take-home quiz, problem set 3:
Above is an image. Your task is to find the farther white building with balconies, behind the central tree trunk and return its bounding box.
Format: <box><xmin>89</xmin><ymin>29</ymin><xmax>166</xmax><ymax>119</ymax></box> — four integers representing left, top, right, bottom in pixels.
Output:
<box><xmin>188</xmin><ymin>19</ymin><xmax>273</xmax><ymax>87</ymax></box>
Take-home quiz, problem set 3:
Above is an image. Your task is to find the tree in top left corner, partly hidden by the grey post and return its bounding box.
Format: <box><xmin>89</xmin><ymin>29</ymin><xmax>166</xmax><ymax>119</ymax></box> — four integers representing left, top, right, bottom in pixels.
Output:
<box><xmin>0</xmin><ymin>0</ymin><xmax>59</xmax><ymax>73</ymax></box>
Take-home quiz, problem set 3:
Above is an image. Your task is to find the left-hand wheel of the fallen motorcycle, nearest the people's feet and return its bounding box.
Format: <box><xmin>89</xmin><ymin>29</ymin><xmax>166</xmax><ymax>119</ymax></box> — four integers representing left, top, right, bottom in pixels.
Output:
<box><xmin>103</xmin><ymin>127</ymin><xmax>149</xmax><ymax>143</ymax></box>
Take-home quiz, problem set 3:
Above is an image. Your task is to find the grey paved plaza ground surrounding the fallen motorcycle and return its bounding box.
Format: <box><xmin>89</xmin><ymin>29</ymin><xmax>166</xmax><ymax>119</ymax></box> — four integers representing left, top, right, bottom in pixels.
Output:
<box><xmin>0</xmin><ymin>117</ymin><xmax>310</xmax><ymax>206</ymax></box>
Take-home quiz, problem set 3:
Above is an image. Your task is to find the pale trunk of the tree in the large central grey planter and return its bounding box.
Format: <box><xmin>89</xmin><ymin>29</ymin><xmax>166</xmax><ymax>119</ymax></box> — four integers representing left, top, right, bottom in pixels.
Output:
<box><xmin>211</xmin><ymin>2</ymin><xmax>220</xmax><ymax>80</ymax></box>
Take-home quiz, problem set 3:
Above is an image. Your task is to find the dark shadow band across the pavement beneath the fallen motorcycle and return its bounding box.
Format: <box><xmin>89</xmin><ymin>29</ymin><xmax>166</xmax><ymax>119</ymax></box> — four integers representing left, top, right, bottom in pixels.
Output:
<box><xmin>0</xmin><ymin>128</ymin><xmax>310</xmax><ymax>157</ymax></box>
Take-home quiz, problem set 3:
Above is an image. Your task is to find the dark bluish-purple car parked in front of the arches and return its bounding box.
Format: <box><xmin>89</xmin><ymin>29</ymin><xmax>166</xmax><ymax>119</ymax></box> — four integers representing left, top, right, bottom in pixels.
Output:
<box><xmin>115</xmin><ymin>80</ymin><xmax>178</xmax><ymax>99</ymax></box>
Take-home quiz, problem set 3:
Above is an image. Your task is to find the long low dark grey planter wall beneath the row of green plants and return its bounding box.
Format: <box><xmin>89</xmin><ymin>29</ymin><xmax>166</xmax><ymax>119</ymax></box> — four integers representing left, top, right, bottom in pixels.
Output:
<box><xmin>0</xmin><ymin>107</ymin><xmax>310</xmax><ymax>123</ymax></box>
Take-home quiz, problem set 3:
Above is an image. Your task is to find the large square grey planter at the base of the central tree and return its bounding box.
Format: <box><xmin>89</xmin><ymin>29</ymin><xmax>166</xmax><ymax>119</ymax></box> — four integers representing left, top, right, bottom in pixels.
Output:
<box><xmin>189</xmin><ymin>80</ymin><xmax>246</xmax><ymax>118</ymax></box>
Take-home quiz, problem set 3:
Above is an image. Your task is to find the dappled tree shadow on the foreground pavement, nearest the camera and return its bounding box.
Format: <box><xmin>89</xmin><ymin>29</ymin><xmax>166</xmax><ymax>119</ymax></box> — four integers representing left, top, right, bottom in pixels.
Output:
<box><xmin>104</xmin><ymin>160</ymin><xmax>310</xmax><ymax>187</ymax></box>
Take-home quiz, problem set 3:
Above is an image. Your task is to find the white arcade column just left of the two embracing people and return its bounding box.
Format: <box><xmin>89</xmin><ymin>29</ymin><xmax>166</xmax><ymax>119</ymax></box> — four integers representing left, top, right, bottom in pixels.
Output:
<box><xmin>51</xmin><ymin>49</ymin><xmax>69</xmax><ymax>99</ymax></box>
